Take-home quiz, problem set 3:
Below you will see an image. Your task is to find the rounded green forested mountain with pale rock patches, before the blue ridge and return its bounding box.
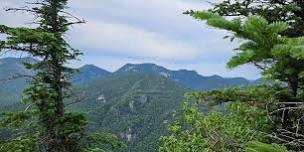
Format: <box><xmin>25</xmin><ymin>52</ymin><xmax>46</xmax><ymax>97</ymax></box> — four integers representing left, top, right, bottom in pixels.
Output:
<box><xmin>69</xmin><ymin>72</ymin><xmax>189</xmax><ymax>152</ymax></box>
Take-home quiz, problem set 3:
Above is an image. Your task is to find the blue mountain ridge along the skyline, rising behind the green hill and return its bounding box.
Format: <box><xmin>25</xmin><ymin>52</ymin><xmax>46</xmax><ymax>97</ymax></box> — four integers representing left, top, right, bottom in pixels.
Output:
<box><xmin>0</xmin><ymin>57</ymin><xmax>261</xmax><ymax>95</ymax></box>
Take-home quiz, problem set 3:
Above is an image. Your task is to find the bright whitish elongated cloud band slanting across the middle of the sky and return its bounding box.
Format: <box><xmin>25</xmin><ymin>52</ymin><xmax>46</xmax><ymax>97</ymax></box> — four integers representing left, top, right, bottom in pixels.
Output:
<box><xmin>71</xmin><ymin>21</ymin><xmax>202</xmax><ymax>60</ymax></box>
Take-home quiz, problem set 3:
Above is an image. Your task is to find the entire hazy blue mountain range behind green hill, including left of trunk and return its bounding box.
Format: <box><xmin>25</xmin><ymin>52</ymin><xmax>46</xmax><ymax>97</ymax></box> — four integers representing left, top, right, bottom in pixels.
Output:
<box><xmin>0</xmin><ymin>58</ymin><xmax>256</xmax><ymax>111</ymax></box>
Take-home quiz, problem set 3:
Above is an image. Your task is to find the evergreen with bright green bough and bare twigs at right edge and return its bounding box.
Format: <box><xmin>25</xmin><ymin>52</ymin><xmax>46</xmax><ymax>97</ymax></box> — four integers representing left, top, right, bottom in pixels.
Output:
<box><xmin>182</xmin><ymin>11</ymin><xmax>304</xmax><ymax>150</ymax></box>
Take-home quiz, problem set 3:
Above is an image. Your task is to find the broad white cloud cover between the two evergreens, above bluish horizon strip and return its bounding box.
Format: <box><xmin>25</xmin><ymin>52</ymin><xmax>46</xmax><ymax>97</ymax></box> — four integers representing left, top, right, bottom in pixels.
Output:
<box><xmin>70</xmin><ymin>0</ymin><xmax>231</xmax><ymax>61</ymax></box>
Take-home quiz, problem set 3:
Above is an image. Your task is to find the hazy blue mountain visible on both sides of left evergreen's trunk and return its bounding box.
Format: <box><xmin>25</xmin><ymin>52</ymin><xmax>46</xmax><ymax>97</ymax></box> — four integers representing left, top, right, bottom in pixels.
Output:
<box><xmin>0</xmin><ymin>57</ymin><xmax>111</xmax><ymax>111</ymax></box>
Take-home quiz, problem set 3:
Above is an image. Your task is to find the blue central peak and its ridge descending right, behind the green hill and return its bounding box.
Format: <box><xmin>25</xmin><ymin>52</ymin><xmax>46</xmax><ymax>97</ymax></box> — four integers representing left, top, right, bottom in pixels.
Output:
<box><xmin>115</xmin><ymin>63</ymin><xmax>250</xmax><ymax>90</ymax></box>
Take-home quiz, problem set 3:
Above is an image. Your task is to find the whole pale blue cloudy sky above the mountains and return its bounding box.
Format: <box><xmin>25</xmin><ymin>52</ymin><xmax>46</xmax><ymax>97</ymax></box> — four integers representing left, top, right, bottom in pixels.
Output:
<box><xmin>0</xmin><ymin>0</ymin><xmax>260</xmax><ymax>79</ymax></box>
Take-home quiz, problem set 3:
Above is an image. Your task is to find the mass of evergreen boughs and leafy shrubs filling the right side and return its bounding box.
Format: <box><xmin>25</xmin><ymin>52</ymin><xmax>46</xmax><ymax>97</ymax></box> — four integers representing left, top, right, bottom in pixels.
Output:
<box><xmin>160</xmin><ymin>0</ymin><xmax>304</xmax><ymax>152</ymax></box>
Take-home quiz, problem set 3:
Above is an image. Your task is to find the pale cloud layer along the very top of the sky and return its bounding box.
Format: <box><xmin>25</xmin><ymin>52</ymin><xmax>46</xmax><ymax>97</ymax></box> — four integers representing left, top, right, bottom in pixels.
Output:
<box><xmin>70</xmin><ymin>0</ymin><xmax>211</xmax><ymax>38</ymax></box>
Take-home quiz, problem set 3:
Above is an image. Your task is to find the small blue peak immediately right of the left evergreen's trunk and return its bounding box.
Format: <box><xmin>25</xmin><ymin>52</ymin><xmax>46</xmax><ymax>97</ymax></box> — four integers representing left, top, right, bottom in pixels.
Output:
<box><xmin>72</xmin><ymin>64</ymin><xmax>112</xmax><ymax>85</ymax></box>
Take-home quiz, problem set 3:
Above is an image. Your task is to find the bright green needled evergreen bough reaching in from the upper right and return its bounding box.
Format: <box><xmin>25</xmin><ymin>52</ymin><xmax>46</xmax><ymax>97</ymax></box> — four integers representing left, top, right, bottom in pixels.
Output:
<box><xmin>189</xmin><ymin>11</ymin><xmax>304</xmax><ymax>96</ymax></box>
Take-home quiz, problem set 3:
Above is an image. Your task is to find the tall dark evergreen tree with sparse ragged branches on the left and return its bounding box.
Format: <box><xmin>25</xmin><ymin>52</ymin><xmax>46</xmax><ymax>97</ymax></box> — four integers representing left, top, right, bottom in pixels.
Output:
<box><xmin>0</xmin><ymin>0</ymin><xmax>123</xmax><ymax>152</ymax></box>
